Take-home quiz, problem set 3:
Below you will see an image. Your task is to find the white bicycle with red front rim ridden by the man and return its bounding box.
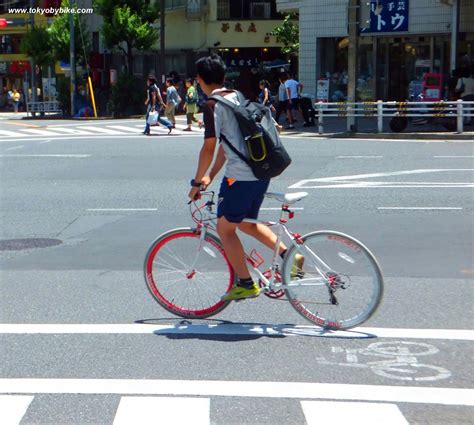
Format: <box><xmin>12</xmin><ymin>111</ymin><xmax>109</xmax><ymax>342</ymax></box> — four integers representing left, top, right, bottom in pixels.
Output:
<box><xmin>144</xmin><ymin>191</ymin><xmax>383</xmax><ymax>329</ymax></box>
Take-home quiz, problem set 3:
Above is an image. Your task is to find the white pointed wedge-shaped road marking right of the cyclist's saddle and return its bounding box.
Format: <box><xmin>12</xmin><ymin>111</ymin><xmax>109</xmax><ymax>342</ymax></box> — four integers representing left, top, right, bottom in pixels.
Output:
<box><xmin>289</xmin><ymin>168</ymin><xmax>474</xmax><ymax>189</ymax></box>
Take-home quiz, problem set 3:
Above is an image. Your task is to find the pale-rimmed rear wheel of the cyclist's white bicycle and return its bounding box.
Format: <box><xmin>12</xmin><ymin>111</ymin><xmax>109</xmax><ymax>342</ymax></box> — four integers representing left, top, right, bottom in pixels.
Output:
<box><xmin>282</xmin><ymin>231</ymin><xmax>383</xmax><ymax>329</ymax></box>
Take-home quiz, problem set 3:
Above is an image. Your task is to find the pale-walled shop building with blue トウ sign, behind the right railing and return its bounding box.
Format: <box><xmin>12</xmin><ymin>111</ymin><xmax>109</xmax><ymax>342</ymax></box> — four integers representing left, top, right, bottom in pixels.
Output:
<box><xmin>277</xmin><ymin>0</ymin><xmax>474</xmax><ymax>101</ymax></box>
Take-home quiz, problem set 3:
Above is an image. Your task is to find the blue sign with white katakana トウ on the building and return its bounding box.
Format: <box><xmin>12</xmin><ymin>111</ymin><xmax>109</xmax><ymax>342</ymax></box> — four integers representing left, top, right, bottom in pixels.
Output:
<box><xmin>363</xmin><ymin>0</ymin><xmax>409</xmax><ymax>32</ymax></box>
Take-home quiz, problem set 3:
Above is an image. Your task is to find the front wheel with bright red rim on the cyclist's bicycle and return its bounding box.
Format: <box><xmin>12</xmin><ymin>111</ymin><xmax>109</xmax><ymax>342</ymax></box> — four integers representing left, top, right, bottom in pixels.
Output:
<box><xmin>144</xmin><ymin>228</ymin><xmax>234</xmax><ymax>318</ymax></box>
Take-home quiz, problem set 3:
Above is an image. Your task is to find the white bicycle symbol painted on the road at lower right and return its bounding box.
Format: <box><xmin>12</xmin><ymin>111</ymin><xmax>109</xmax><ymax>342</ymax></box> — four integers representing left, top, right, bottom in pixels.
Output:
<box><xmin>318</xmin><ymin>341</ymin><xmax>451</xmax><ymax>382</ymax></box>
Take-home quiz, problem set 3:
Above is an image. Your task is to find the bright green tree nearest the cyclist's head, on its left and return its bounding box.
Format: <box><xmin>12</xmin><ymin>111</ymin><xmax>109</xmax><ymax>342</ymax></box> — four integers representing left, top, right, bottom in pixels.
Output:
<box><xmin>94</xmin><ymin>0</ymin><xmax>159</xmax><ymax>72</ymax></box>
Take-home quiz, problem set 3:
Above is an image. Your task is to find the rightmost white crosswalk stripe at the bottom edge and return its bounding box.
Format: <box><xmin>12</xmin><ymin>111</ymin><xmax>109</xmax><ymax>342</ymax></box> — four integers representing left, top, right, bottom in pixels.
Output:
<box><xmin>301</xmin><ymin>401</ymin><xmax>408</xmax><ymax>425</ymax></box>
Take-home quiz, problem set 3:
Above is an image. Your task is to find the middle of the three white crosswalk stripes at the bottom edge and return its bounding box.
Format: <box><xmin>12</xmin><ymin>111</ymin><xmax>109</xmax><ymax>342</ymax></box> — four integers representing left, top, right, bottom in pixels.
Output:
<box><xmin>113</xmin><ymin>397</ymin><xmax>210</xmax><ymax>425</ymax></box>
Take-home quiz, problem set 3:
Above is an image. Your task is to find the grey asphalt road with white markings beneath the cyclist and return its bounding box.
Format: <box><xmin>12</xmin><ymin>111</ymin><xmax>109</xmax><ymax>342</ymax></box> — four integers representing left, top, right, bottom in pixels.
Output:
<box><xmin>0</xmin><ymin>117</ymin><xmax>474</xmax><ymax>424</ymax></box>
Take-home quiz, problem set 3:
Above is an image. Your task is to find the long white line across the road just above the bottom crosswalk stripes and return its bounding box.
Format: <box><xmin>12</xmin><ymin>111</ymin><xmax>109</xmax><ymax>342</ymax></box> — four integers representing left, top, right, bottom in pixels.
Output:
<box><xmin>0</xmin><ymin>378</ymin><xmax>474</xmax><ymax>406</ymax></box>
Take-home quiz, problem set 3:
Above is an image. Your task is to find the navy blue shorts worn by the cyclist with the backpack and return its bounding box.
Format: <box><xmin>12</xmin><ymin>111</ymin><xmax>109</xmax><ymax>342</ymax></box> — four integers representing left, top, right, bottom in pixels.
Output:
<box><xmin>217</xmin><ymin>177</ymin><xmax>270</xmax><ymax>223</ymax></box>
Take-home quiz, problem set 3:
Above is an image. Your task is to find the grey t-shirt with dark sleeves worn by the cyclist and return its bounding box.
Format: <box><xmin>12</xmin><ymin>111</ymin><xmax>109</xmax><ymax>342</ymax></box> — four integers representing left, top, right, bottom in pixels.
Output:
<box><xmin>204</xmin><ymin>90</ymin><xmax>258</xmax><ymax>181</ymax></box>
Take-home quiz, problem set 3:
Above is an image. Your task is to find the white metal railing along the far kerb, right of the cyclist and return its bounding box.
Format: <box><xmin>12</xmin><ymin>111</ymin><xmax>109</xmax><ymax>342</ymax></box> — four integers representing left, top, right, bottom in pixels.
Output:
<box><xmin>315</xmin><ymin>100</ymin><xmax>474</xmax><ymax>133</ymax></box>
